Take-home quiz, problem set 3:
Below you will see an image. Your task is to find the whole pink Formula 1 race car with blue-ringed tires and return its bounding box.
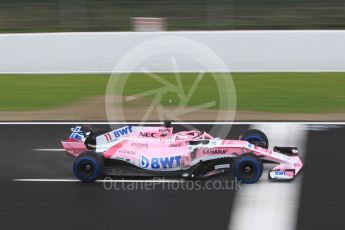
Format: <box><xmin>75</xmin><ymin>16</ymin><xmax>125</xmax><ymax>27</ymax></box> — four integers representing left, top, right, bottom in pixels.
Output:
<box><xmin>62</xmin><ymin>123</ymin><xmax>303</xmax><ymax>183</ymax></box>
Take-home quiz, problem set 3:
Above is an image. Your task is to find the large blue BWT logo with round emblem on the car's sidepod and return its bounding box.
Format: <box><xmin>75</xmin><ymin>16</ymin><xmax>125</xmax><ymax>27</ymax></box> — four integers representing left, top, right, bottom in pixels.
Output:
<box><xmin>139</xmin><ymin>156</ymin><xmax>182</xmax><ymax>169</ymax></box>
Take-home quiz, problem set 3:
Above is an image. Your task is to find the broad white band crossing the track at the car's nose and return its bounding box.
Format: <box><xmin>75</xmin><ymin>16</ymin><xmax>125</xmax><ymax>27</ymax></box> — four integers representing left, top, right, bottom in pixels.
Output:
<box><xmin>229</xmin><ymin>124</ymin><xmax>307</xmax><ymax>230</ymax></box>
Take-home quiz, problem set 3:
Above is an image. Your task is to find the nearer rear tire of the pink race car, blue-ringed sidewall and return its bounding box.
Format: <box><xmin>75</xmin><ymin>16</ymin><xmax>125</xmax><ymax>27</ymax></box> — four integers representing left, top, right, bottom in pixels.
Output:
<box><xmin>73</xmin><ymin>153</ymin><xmax>103</xmax><ymax>182</ymax></box>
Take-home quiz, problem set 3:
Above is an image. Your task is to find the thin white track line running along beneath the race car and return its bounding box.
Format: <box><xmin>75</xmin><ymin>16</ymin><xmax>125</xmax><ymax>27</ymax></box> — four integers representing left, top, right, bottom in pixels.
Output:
<box><xmin>12</xmin><ymin>178</ymin><xmax>185</xmax><ymax>183</ymax></box>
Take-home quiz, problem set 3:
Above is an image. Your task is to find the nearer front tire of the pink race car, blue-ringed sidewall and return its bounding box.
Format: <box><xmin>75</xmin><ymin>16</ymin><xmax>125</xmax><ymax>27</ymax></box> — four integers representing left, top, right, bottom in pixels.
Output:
<box><xmin>233</xmin><ymin>153</ymin><xmax>263</xmax><ymax>184</ymax></box>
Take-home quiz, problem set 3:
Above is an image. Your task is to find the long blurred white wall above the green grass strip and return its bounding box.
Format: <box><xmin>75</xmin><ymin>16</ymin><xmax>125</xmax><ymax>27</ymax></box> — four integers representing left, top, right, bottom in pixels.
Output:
<box><xmin>0</xmin><ymin>30</ymin><xmax>345</xmax><ymax>73</ymax></box>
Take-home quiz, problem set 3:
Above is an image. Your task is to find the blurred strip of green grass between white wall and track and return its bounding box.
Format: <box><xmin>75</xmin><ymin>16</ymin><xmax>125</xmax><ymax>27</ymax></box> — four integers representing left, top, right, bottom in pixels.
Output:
<box><xmin>0</xmin><ymin>73</ymin><xmax>345</xmax><ymax>113</ymax></box>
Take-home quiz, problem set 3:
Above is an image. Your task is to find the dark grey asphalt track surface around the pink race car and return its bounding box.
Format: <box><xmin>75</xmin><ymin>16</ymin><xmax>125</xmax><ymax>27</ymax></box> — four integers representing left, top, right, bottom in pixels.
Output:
<box><xmin>0</xmin><ymin>124</ymin><xmax>345</xmax><ymax>230</ymax></box>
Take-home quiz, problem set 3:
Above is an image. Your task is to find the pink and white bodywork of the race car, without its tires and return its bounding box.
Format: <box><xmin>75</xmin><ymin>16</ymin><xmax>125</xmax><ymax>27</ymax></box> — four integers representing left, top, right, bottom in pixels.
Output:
<box><xmin>62</xmin><ymin>127</ymin><xmax>303</xmax><ymax>178</ymax></box>
